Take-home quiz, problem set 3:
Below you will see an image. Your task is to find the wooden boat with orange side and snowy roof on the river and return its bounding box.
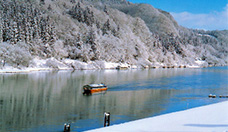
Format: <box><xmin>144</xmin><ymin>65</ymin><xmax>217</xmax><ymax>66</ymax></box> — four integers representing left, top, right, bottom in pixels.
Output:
<box><xmin>83</xmin><ymin>83</ymin><xmax>108</xmax><ymax>94</ymax></box>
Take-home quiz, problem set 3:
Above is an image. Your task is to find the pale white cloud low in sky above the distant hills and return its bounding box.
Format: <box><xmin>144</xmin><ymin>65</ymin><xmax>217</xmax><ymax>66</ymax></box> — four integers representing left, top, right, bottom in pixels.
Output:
<box><xmin>171</xmin><ymin>4</ymin><xmax>228</xmax><ymax>30</ymax></box>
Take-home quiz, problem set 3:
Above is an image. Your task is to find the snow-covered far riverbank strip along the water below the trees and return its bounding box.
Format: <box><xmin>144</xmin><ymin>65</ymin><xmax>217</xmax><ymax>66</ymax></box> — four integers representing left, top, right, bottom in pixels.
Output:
<box><xmin>0</xmin><ymin>58</ymin><xmax>207</xmax><ymax>73</ymax></box>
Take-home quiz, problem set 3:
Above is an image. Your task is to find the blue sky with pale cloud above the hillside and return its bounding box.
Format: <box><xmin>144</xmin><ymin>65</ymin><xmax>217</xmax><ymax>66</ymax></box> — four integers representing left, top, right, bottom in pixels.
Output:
<box><xmin>129</xmin><ymin>0</ymin><xmax>228</xmax><ymax>30</ymax></box>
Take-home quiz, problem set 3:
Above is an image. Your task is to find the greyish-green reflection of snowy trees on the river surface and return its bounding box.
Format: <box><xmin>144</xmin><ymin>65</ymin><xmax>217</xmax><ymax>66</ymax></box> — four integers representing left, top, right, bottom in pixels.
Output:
<box><xmin>0</xmin><ymin>70</ymin><xmax>194</xmax><ymax>131</ymax></box>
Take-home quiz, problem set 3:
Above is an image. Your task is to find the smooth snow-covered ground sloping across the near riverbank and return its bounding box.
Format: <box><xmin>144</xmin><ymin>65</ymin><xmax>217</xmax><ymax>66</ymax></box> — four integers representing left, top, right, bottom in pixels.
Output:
<box><xmin>87</xmin><ymin>101</ymin><xmax>228</xmax><ymax>132</ymax></box>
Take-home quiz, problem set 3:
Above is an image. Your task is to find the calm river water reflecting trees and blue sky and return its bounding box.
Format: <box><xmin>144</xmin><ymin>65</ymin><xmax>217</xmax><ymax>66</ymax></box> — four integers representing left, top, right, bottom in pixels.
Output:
<box><xmin>0</xmin><ymin>67</ymin><xmax>228</xmax><ymax>132</ymax></box>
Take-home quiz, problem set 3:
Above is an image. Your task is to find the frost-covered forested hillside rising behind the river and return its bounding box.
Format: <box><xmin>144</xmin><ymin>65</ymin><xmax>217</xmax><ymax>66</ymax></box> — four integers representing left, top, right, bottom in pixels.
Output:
<box><xmin>0</xmin><ymin>0</ymin><xmax>228</xmax><ymax>69</ymax></box>
